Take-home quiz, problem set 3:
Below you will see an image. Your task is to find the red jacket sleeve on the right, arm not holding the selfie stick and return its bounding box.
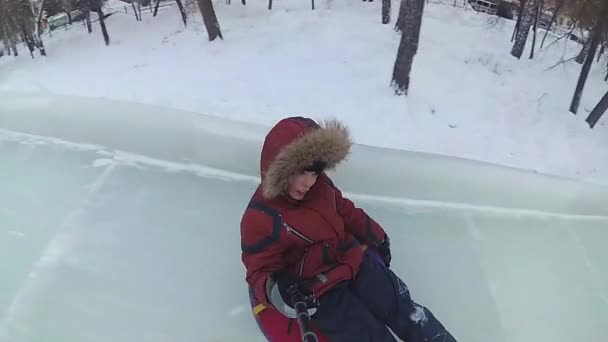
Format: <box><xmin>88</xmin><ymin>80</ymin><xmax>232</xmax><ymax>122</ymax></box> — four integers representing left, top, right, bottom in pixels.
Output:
<box><xmin>327</xmin><ymin>177</ymin><xmax>386</xmax><ymax>246</ymax></box>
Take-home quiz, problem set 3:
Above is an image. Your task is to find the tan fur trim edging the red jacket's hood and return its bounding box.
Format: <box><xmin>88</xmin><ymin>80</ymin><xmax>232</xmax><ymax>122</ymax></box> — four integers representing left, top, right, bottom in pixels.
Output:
<box><xmin>262</xmin><ymin>120</ymin><xmax>352</xmax><ymax>198</ymax></box>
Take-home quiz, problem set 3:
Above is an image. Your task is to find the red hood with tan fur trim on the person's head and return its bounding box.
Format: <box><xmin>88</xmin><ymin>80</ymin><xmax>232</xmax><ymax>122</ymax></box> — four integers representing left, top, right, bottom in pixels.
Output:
<box><xmin>260</xmin><ymin>117</ymin><xmax>352</xmax><ymax>199</ymax></box>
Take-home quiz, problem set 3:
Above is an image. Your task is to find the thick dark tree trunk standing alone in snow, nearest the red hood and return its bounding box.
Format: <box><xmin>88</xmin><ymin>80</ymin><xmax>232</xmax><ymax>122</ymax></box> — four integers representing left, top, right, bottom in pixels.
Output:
<box><xmin>391</xmin><ymin>0</ymin><xmax>425</xmax><ymax>95</ymax></box>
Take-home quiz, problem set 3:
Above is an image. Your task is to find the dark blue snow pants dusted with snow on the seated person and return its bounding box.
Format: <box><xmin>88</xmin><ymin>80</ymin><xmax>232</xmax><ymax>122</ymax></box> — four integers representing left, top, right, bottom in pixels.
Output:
<box><xmin>312</xmin><ymin>250</ymin><xmax>456</xmax><ymax>342</ymax></box>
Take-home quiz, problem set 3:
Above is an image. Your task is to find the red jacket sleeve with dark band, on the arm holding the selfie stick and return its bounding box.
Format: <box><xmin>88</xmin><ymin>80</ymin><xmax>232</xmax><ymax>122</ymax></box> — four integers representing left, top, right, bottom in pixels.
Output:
<box><xmin>241</xmin><ymin>211</ymin><xmax>286</xmax><ymax>306</ymax></box>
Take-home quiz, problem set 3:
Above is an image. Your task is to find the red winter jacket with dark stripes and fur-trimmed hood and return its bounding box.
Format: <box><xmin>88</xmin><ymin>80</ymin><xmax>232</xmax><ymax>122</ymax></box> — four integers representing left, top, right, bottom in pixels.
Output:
<box><xmin>241</xmin><ymin>117</ymin><xmax>385</xmax><ymax>306</ymax></box>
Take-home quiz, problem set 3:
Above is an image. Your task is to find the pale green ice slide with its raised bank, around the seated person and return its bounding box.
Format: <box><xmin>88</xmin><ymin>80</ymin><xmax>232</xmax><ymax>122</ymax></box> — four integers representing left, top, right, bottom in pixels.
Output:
<box><xmin>0</xmin><ymin>93</ymin><xmax>608</xmax><ymax>342</ymax></box>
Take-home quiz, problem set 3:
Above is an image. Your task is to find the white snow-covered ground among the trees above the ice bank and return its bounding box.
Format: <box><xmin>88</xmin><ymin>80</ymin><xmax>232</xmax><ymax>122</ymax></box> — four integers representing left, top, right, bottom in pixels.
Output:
<box><xmin>0</xmin><ymin>0</ymin><xmax>608</xmax><ymax>182</ymax></box>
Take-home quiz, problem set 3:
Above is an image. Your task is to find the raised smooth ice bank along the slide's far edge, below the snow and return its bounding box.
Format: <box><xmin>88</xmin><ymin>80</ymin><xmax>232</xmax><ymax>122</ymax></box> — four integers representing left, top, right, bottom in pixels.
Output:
<box><xmin>0</xmin><ymin>93</ymin><xmax>608</xmax><ymax>217</ymax></box>
